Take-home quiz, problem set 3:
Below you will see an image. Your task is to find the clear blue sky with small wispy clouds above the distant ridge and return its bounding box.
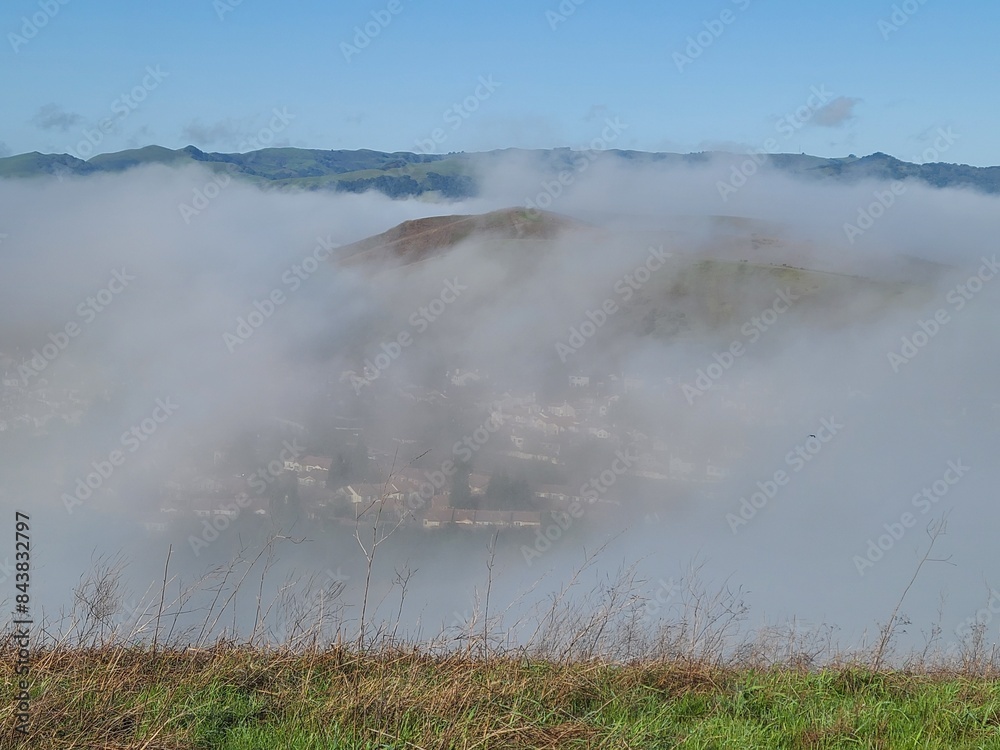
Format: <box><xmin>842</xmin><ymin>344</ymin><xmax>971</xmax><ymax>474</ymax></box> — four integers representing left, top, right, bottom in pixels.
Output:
<box><xmin>0</xmin><ymin>0</ymin><xmax>1000</xmax><ymax>166</ymax></box>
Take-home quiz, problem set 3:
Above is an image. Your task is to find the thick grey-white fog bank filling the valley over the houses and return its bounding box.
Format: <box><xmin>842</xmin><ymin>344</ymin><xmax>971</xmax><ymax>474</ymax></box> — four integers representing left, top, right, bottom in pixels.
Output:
<box><xmin>0</xmin><ymin>154</ymin><xmax>1000</xmax><ymax>664</ymax></box>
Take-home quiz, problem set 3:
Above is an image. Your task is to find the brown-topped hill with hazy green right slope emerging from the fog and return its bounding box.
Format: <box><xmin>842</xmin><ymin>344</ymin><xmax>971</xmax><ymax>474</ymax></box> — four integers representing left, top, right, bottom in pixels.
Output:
<box><xmin>335</xmin><ymin>208</ymin><xmax>947</xmax><ymax>350</ymax></box>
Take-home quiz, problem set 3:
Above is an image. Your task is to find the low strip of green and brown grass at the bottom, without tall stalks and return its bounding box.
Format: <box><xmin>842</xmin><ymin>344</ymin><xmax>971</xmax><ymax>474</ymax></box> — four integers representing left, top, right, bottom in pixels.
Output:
<box><xmin>0</xmin><ymin>646</ymin><xmax>1000</xmax><ymax>750</ymax></box>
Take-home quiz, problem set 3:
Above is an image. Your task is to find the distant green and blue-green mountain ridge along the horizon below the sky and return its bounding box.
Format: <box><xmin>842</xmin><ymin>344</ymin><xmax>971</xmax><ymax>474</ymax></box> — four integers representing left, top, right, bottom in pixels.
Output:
<box><xmin>0</xmin><ymin>146</ymin><xmax>1000</xmax><ymax>200</ymax></box>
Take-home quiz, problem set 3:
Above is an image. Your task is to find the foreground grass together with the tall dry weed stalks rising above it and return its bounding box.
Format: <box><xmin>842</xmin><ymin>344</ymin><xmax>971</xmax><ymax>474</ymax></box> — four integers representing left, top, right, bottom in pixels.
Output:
<box><xmin>0</xmin><ymin>536</ymin><xmax>1000</xmax><ymax>750</ymax></box>
